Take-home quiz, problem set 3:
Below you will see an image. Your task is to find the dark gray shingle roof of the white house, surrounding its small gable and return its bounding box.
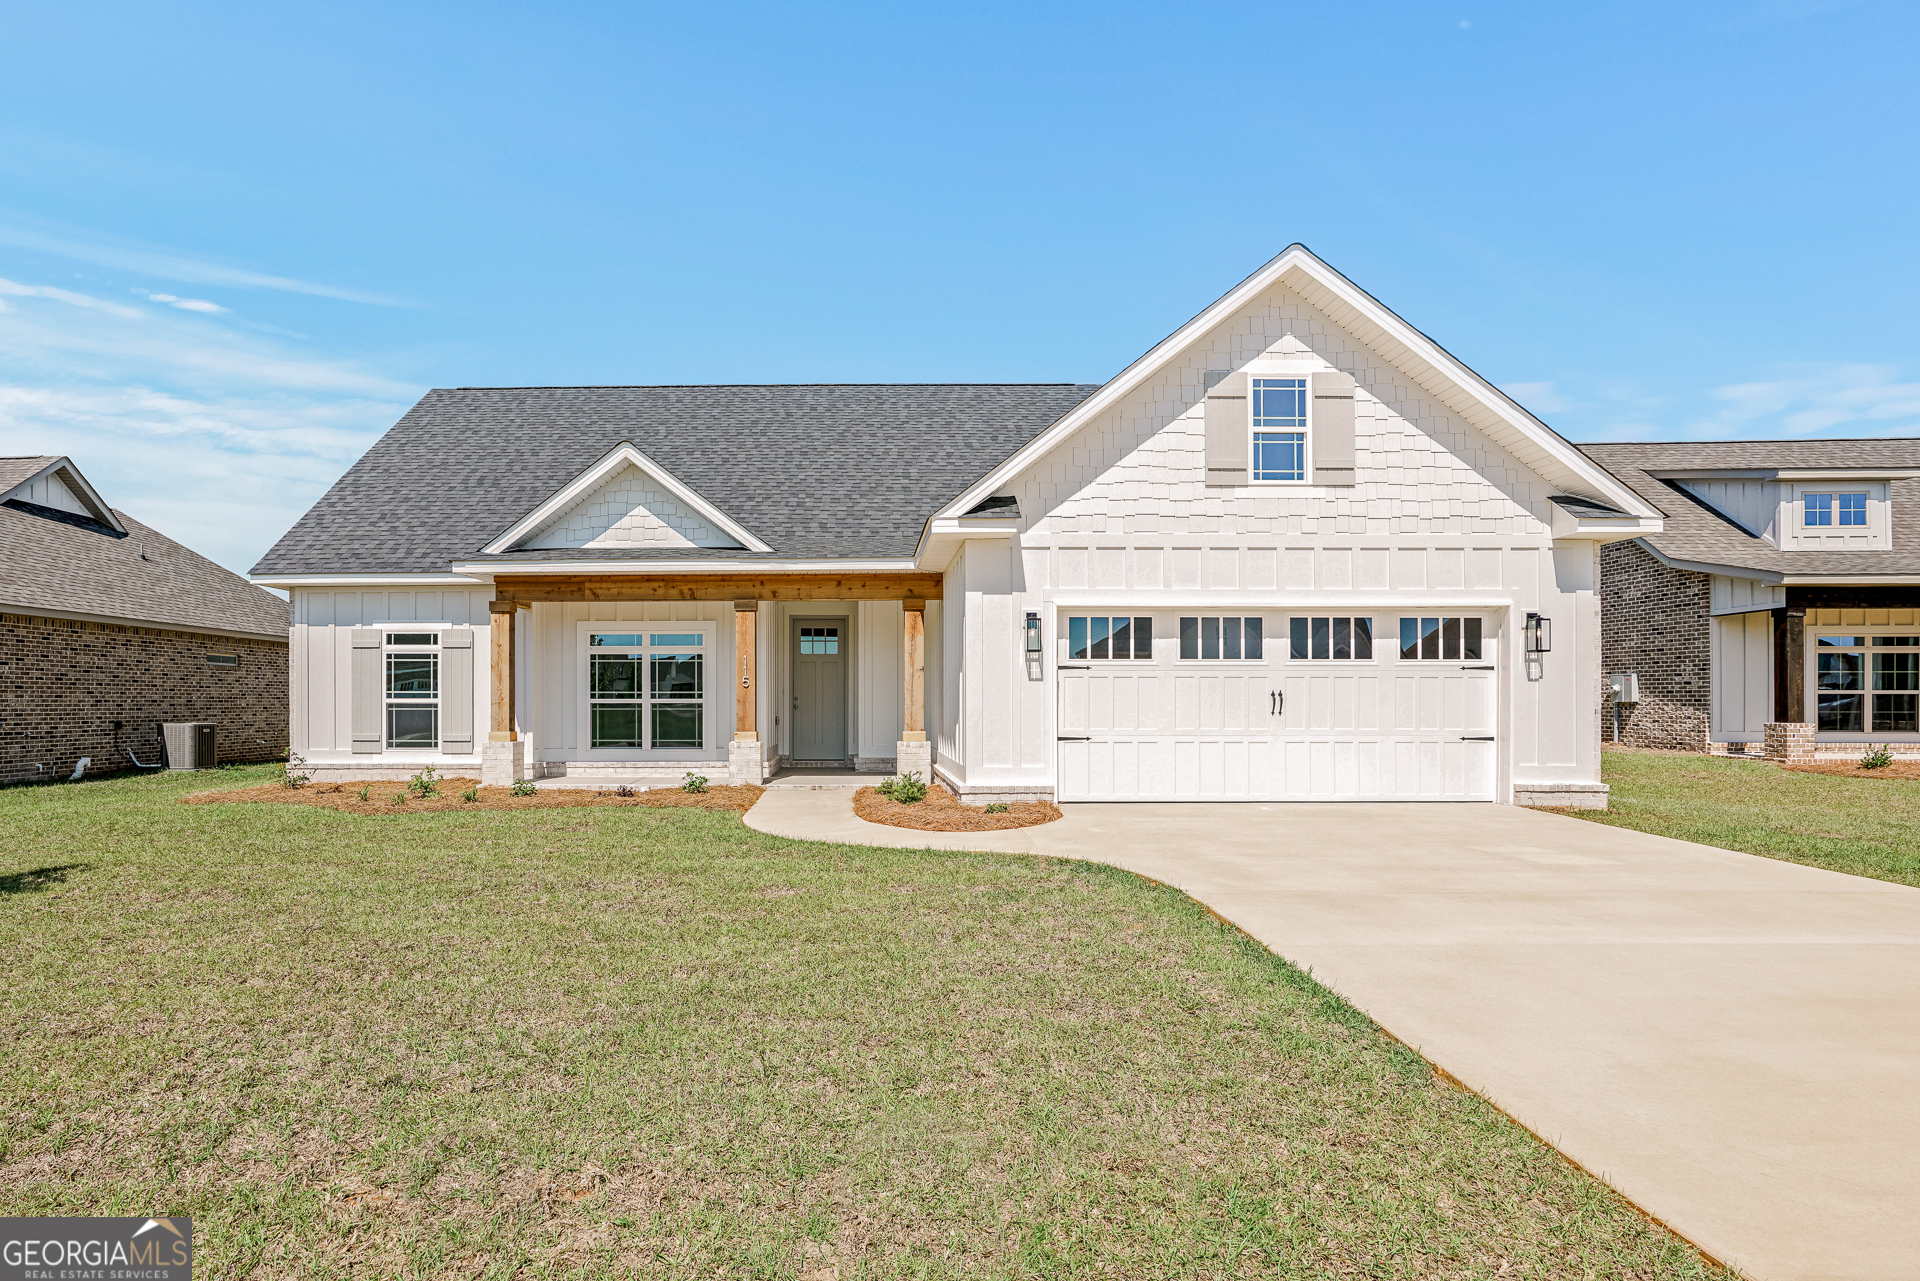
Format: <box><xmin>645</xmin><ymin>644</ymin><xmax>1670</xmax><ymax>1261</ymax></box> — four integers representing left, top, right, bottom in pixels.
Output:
<box><xmin>253</xmin><ymin>382</ymin><xmax>1098</xmax><ymax>574</ymax></box>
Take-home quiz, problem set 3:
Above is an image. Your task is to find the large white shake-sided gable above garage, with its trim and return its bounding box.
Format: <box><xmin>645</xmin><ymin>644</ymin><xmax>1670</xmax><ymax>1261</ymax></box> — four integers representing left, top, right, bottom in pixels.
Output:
<box><xmin>931</xmin><ymin>246</ymin><xmax>1661</xmax><ymax>556</ymax></box>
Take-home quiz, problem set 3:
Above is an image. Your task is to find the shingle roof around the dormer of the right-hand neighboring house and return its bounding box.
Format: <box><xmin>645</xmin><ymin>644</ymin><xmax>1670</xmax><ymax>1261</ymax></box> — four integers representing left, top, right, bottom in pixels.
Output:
<box><xmin>1580</xmin><ymin>436</ymin><xmax>1920</xmax><ymax>576</ymax></box>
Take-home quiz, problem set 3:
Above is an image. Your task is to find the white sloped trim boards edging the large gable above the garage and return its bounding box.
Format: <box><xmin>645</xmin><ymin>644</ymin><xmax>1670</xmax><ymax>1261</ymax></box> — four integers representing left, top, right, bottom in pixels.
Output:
<box><xmin>922</xmin><ymin>244</ymin><xmax>1663</xmax><ymax>545</ymax></box>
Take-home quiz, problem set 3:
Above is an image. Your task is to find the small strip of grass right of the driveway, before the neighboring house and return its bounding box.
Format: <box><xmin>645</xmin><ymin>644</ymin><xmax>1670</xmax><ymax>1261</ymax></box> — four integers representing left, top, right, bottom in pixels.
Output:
<box><xmin>1572</xmin><ymin>749</ymin><xmax>1920</xmax><ymax>885</ymax></box>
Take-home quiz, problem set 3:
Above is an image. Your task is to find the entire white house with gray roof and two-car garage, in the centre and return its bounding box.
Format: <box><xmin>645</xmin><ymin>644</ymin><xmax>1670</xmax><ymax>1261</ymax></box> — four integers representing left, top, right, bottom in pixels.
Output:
<box><xmin>253</xmin><ymin>246</ymin><xmax>1661</xmax><ymax>805</ymax></box>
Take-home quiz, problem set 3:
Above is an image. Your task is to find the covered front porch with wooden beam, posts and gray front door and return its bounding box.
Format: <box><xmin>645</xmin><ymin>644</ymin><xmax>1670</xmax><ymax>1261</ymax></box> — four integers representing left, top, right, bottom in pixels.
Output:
<box><xmin>482</xmin><ymin>570</ymin><xmax>941</xmax><ymax>787</ymax></box>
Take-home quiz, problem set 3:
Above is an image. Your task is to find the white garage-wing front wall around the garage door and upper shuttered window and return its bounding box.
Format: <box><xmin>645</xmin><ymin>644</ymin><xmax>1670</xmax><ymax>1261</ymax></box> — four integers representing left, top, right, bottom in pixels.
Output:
<box><xmin>937</xmin><ymin>286</ymin><xmax>1601</xmax><ymax>802</ymax></box>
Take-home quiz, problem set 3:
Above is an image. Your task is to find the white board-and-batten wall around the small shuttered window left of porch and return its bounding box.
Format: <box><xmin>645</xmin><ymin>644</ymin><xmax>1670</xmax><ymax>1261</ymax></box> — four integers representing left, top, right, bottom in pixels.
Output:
<box><xmin>288</xmin><ymin>588</ymin><xmax>493</xmax><ymax>772</ymax></box>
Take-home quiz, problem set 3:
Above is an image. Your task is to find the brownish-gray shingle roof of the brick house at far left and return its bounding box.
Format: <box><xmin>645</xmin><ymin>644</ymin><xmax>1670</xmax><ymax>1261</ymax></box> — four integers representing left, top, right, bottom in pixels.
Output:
<box><xmin>0</xmin><ymin>499</ymin><xmax>290</xmax><ymax>640</ymax></box>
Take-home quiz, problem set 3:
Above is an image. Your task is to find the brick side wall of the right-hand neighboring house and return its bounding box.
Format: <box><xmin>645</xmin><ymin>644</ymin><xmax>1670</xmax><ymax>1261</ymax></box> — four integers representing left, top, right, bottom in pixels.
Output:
<box><xmin>1599</xmin><ymin>542</ymin><xmax>1713</xmax><ymax>751</ymax></box>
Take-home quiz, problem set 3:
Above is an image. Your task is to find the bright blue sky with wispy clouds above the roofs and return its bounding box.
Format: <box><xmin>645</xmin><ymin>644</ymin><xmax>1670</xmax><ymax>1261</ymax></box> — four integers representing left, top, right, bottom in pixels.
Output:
<box><xmin>0</xmin><ymin>0</ymin><xmax>1920</xmax><ymax>570</ymax></box>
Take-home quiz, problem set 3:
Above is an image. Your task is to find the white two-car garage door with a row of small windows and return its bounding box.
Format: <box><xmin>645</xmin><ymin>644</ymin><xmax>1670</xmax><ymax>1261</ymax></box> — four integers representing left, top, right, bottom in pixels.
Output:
<box><xmin>1058</xmin><ymin>611</ymin><xmax>1496</xmax><ymax>801</ymax></box>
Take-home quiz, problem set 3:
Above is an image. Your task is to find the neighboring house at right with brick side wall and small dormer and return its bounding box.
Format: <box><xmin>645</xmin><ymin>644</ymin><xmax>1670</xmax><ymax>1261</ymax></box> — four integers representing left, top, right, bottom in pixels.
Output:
<box><xmin>1584</xmin><ymin>440</ymin><xmax>1920</xmax><ymax>757</ymax></box>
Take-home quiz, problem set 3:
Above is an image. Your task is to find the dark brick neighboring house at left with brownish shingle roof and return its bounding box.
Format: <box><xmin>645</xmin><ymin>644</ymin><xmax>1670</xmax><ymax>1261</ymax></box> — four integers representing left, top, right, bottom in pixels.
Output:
<box><xmin>0</xmin><ymin>457</ymin><xmax>288</xmax><ymax>784</ymax></box>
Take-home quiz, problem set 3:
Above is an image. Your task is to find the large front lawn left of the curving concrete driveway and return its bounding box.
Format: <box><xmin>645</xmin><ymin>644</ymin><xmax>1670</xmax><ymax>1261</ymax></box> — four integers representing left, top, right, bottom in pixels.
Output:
<box><xmin>0</xmin><ymin>768</ymin><xmax>1720</xmax><ymax>1281</ymax></box>
